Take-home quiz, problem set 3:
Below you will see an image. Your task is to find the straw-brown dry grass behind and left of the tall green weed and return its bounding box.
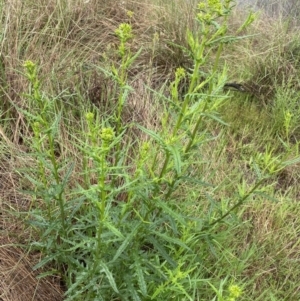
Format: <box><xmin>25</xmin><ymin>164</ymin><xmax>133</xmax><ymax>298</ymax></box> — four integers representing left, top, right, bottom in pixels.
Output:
<box><xmin>0</xmin><ymin>0</ymin><xmax>185</xmax><ymax>301</ymax></box>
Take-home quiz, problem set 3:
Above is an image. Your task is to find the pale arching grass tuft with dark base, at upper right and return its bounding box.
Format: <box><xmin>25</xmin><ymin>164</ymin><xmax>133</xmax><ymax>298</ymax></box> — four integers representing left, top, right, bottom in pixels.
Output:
<box><xmin>226</xmin><ymin>9</ymin><xmax>300</xmax><ymax>106</ymax></box>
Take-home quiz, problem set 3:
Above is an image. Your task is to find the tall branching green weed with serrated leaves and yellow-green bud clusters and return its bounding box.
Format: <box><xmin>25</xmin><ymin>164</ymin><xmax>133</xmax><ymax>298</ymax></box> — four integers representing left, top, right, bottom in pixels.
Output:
<box><xmin>18</xmin><ymin>0</ymin><xmax>298</xmax><ymax>301</ymax></box>
